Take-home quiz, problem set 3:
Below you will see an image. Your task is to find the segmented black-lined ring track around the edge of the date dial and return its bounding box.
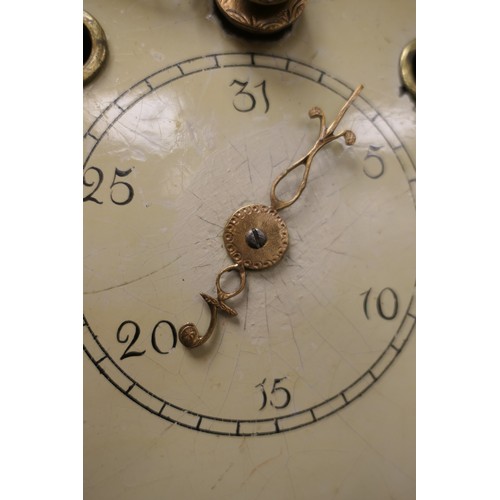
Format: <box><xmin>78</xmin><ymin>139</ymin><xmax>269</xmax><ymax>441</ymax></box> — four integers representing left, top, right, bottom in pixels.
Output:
<box><xmin>83</xmin><ymin>52</ymin><xmax>416</xmax><ymax>436</ymax></box>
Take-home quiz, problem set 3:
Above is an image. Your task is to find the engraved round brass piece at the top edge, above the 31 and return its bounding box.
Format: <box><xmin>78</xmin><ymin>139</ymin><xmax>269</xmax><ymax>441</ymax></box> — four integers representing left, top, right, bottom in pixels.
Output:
<box><xmin>216</xmin><ymin>0</ymin><xmax>307</xmax><ymax>34</ymax></box>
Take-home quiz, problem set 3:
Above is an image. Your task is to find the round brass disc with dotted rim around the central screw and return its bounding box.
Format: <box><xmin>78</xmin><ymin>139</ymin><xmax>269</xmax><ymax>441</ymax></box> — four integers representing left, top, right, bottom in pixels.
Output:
<box><xmin>222</xmin><ymin>205</ymin><xmax>288</xmax><ymax>269</ymax></box>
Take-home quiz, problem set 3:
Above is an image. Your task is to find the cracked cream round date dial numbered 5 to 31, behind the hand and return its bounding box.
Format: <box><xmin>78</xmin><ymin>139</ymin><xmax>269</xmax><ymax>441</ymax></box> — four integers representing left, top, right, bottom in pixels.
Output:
<box><xmin>84</xmin><ymin>53</ymin><xmax>415</xmax><ymax>435</ymax></box>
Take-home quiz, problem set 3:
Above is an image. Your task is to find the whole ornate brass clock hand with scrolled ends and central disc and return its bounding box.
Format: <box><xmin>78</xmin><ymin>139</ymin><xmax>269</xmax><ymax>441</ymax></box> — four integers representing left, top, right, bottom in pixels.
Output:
<box><xmin>179</xmin><ymin>85</ymin><xmax>363</xmax><ymax>348</ymax></box>
